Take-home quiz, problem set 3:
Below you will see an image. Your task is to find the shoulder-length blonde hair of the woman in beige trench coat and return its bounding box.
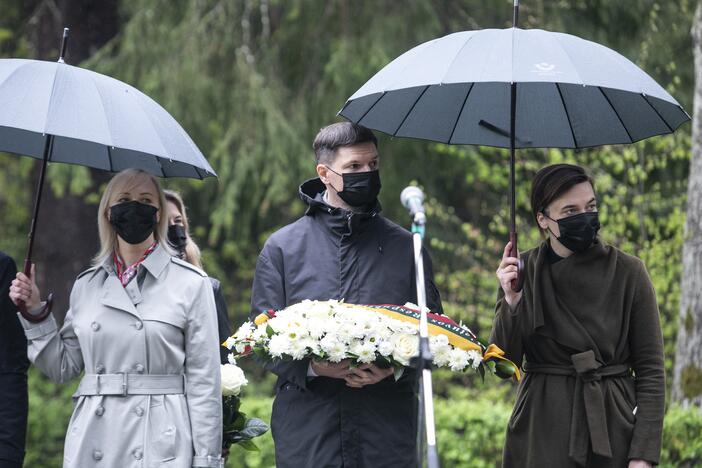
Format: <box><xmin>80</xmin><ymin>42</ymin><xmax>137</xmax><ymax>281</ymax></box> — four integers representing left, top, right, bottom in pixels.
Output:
<box><xmin>93</xmin><ymin>169</ymin><xmax>175</xmax><ymax>265</ymax></box>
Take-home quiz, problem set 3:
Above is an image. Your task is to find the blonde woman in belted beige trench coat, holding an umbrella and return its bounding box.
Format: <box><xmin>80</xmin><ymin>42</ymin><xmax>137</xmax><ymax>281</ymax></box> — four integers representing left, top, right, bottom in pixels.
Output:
<box><xmin>10</xmin><ymin>169</ymin><xmax>222</xmax><ymax>468</ymax></box>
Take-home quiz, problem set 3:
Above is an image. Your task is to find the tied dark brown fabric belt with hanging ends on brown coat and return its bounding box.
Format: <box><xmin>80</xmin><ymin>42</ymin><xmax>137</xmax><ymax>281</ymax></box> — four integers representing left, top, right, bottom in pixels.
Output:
<box><xmin>524</xmin><ymin>350</ymin><xmax>630</xmax><ymax>466</ymax></box>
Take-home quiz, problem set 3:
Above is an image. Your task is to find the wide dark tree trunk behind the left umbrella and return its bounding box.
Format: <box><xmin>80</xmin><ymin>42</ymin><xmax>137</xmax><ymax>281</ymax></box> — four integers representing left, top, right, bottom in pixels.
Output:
<box><xmin>30</xmin><ymin>0</ymin><xmax>119</xmax><ymax>321</ymax></box>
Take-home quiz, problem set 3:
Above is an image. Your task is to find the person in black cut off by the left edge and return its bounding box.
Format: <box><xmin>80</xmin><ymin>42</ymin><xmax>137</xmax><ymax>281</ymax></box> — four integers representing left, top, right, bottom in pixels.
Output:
<box><xmin>0</xmin><ymin>252</ymin><xmax>29</xmax><ymax>468</ymax></box>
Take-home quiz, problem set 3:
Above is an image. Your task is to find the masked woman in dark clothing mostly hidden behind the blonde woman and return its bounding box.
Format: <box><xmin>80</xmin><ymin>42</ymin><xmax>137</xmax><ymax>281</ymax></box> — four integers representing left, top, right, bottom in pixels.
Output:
<box><xmin>163</xmin><ymin>190</ymin><xmax>232</xmax><ymax>364</ymax></box>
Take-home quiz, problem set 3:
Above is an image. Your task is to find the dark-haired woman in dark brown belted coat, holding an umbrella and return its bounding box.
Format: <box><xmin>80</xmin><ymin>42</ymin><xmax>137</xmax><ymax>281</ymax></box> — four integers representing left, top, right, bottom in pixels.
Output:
<box><xmin>490</xmin><ymin>164</ymin><xmax>665</xmax><ymax>468</ymax></box>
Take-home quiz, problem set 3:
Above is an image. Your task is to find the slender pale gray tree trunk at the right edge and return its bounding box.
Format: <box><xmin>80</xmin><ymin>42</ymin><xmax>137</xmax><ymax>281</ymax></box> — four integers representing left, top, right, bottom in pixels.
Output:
<box><xmin>673</xmin><ymin>1</ymin><xmax>702</xmax><ymax>406</ymax></box>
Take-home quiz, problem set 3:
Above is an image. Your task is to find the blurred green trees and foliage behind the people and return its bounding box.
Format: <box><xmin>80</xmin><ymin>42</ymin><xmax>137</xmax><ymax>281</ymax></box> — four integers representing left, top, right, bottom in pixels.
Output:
<box><xmin>0</xmin><ymin>0</ymin><xmax>702</xmax><ymax>467</ymax></box>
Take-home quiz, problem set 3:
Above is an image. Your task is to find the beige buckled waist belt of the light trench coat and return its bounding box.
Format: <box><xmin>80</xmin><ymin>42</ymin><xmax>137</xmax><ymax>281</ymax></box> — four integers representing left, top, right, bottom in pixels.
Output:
<box><xmin>73</xmin><ymin>372</ymin><xmax>185</xmax><ymax>397</ymax></box>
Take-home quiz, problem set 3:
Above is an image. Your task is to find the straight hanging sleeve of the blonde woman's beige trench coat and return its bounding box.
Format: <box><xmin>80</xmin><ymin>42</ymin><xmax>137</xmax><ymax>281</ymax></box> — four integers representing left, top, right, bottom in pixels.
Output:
<box><xmin>185</xmin><ymin>277</ymin><xmax>222</xmax><ymax>467</ymax></box>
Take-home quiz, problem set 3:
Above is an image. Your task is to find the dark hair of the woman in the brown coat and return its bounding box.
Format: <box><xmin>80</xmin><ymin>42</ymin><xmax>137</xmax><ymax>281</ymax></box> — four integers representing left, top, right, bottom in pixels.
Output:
<box><xmin>531</xmin><ymin>164</ymin><xmax>595</xmax><ymax>220</ymax></box>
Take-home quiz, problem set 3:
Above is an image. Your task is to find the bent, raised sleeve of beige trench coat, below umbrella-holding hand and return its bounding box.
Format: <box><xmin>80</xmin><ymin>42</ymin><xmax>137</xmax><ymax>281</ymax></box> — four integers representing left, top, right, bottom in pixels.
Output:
<box><xmin>17</xmin><ymin>283</ymin><xmax>83</xmax><ymax>383</ymax></box>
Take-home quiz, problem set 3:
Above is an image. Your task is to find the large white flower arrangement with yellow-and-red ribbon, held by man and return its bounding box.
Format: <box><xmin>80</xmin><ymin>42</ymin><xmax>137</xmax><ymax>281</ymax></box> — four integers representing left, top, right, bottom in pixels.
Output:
<box><xmin>224</xmin><ymin>300</ymin><xmax>519</xmax><ymax>377</ymax></box>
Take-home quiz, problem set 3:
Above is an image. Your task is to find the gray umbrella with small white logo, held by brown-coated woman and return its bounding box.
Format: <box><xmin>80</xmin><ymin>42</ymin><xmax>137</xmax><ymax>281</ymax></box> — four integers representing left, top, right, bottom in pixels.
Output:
<box><xmin>339</xmin><ymin>9</ymin><xmax>690</xmax><ymax>290</ymax></box>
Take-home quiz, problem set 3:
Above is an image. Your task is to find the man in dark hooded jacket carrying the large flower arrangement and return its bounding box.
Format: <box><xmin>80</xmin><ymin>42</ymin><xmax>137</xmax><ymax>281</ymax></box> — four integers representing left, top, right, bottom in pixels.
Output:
<box><xmin>251</xmin><ymin>122</ymin><xmax>441</xmax><ymax>468</ymax></box>
